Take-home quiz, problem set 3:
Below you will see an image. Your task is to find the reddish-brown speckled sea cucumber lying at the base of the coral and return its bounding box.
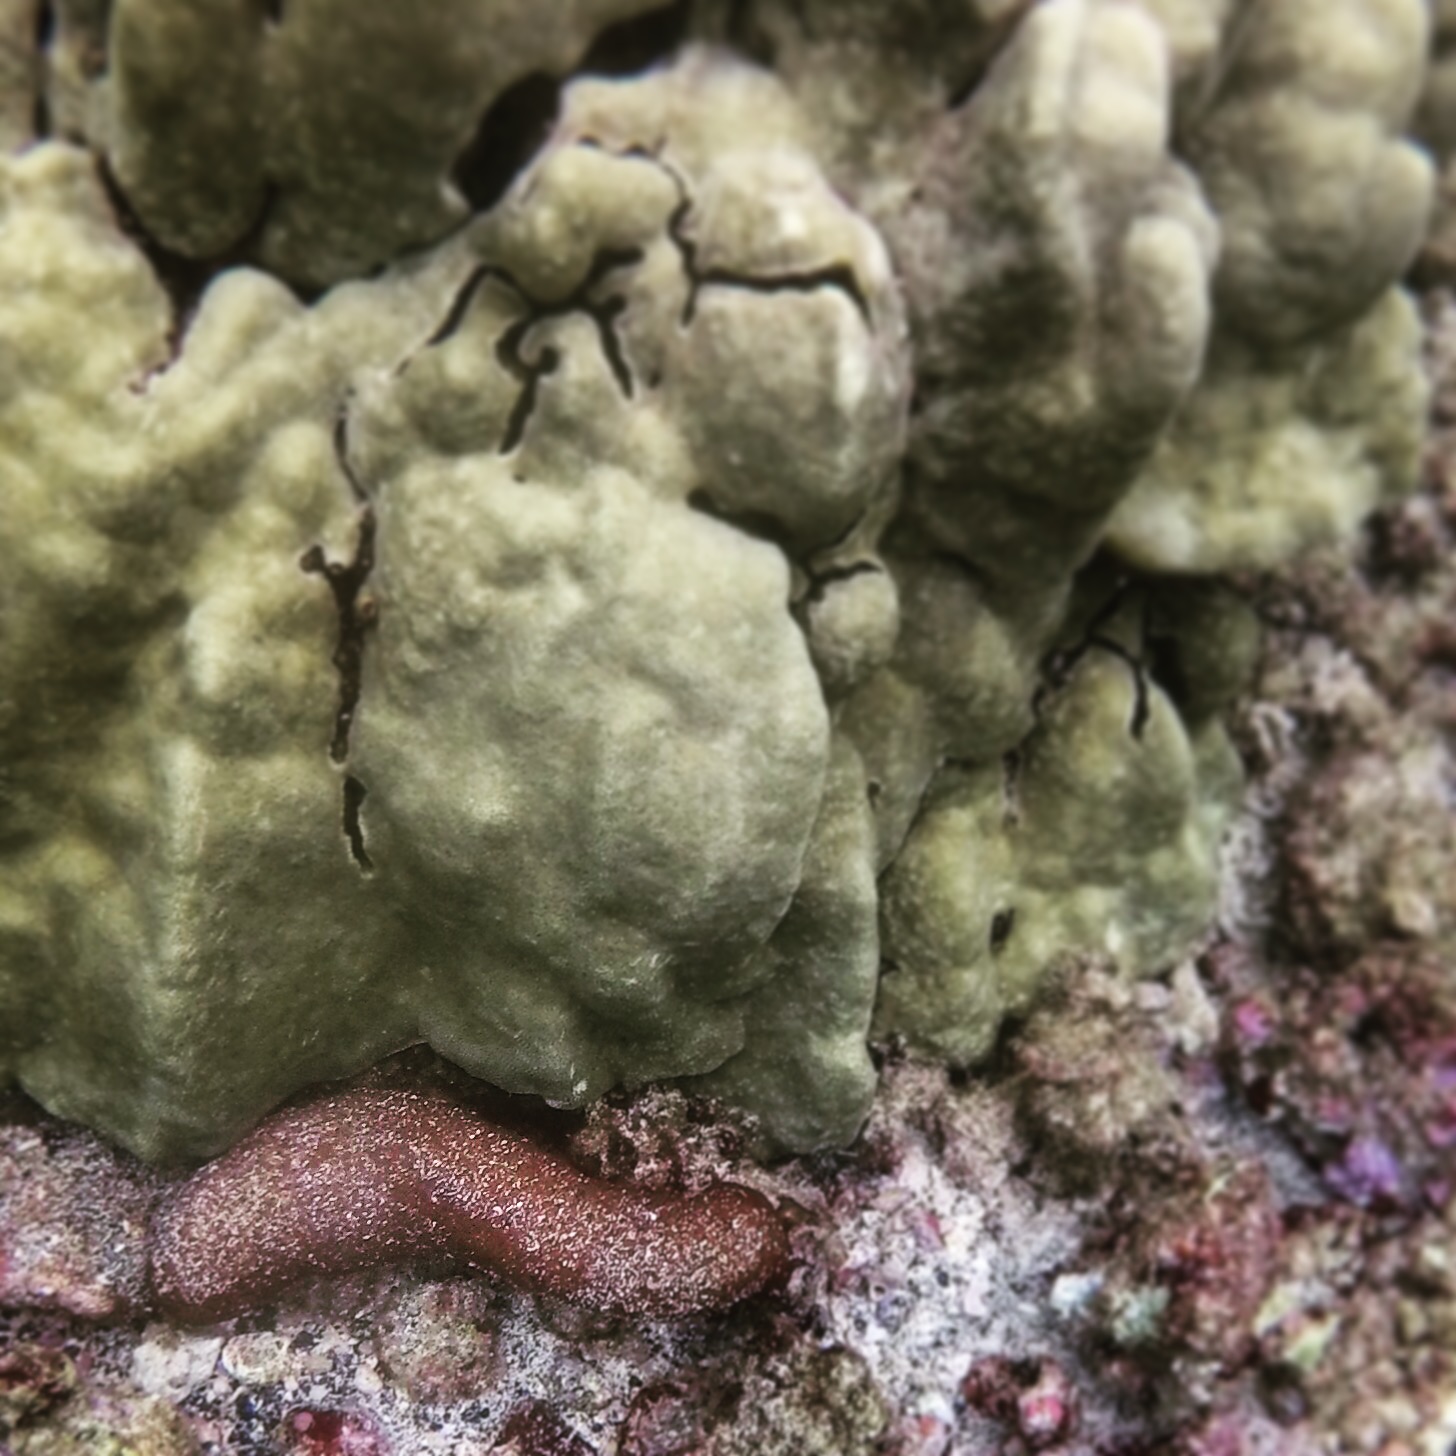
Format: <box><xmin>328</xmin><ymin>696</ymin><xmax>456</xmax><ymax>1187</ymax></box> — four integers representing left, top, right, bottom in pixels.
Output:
<box><xmin>151</xmin><ymin>1091</ymin><xmax>789</xmax><ymax>1324</ymax></box>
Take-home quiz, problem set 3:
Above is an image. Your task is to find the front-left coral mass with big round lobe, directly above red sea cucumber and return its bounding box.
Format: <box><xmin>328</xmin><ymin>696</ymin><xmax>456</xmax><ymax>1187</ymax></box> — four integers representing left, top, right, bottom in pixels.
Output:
<box><xmin>0</xmin><ymin>42</ymin><xmax>906</xmax><ymax>1156</ymax></box>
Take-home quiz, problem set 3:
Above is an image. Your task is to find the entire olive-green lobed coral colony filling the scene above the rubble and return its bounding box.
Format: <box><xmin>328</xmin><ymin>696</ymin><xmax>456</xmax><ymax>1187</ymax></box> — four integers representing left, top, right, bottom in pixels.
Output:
<box><xmin>0</xmin><ymin>0</ymin><xmax>1430</xmax><ymax>1158</ymax></box>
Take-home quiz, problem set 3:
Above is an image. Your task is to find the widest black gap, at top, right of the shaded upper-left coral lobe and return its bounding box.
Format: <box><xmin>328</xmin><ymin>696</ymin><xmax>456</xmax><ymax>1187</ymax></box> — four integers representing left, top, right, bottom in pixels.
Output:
<box><xmin>450</xmin><ymin>0</ymin><xmax>690</xmax><ymax>213</ymax></box>
